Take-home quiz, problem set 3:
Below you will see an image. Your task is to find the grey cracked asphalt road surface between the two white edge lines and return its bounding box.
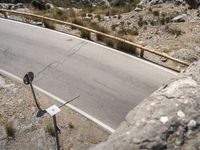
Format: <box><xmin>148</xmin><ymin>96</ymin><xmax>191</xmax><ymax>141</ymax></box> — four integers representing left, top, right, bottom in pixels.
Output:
<box><xmin>0</xmin><ymin>19</ymin><xmax>175</xmax><ymax>129</ymax></box>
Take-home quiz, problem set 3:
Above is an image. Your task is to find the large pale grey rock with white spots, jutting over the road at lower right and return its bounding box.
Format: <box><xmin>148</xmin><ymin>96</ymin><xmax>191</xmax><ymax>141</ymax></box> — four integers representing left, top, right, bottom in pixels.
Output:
<box><xmin>93</xmin><ymin>61</ymin><xmax>200</xmax><ymax>150</ymax></box>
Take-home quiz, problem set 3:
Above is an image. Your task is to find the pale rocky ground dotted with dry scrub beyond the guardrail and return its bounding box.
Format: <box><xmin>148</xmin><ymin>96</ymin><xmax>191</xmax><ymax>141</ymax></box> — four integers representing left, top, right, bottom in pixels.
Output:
<box><xmin>86</xmin><ymin>3</ymin><xmax>200</xmax><ymax>62</ymax></box>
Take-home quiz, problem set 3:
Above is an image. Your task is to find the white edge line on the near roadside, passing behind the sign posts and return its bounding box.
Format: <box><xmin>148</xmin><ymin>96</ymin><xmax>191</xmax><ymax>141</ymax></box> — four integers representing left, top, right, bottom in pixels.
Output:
<box><xmin>0</xmin><ymin>69</ymin><xmax>115</xmax><ymax>133</ymax></box>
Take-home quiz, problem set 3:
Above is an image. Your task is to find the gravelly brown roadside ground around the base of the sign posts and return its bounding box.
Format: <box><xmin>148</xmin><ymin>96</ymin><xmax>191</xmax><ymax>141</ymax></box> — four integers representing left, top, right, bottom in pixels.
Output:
<box><xmin>0</xmin><ymin>75</ymin><xmax>108</xmax><ymax>150</ymax></box>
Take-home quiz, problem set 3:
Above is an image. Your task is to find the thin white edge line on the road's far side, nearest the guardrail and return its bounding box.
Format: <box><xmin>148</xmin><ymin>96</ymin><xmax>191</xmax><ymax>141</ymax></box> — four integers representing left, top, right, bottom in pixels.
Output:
<box><xmin>0</xmin><ymin>18</ymin><xmax>178</xmax><ymax>75</ymax></box>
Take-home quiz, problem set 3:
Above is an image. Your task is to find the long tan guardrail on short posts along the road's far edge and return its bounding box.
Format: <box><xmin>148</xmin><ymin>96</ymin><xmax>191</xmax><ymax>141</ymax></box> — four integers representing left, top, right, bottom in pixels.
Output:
<box><xmin>0</xmin><ymin>9</ymin><xmax>190</xmax><ymax>70</ymax></box>
